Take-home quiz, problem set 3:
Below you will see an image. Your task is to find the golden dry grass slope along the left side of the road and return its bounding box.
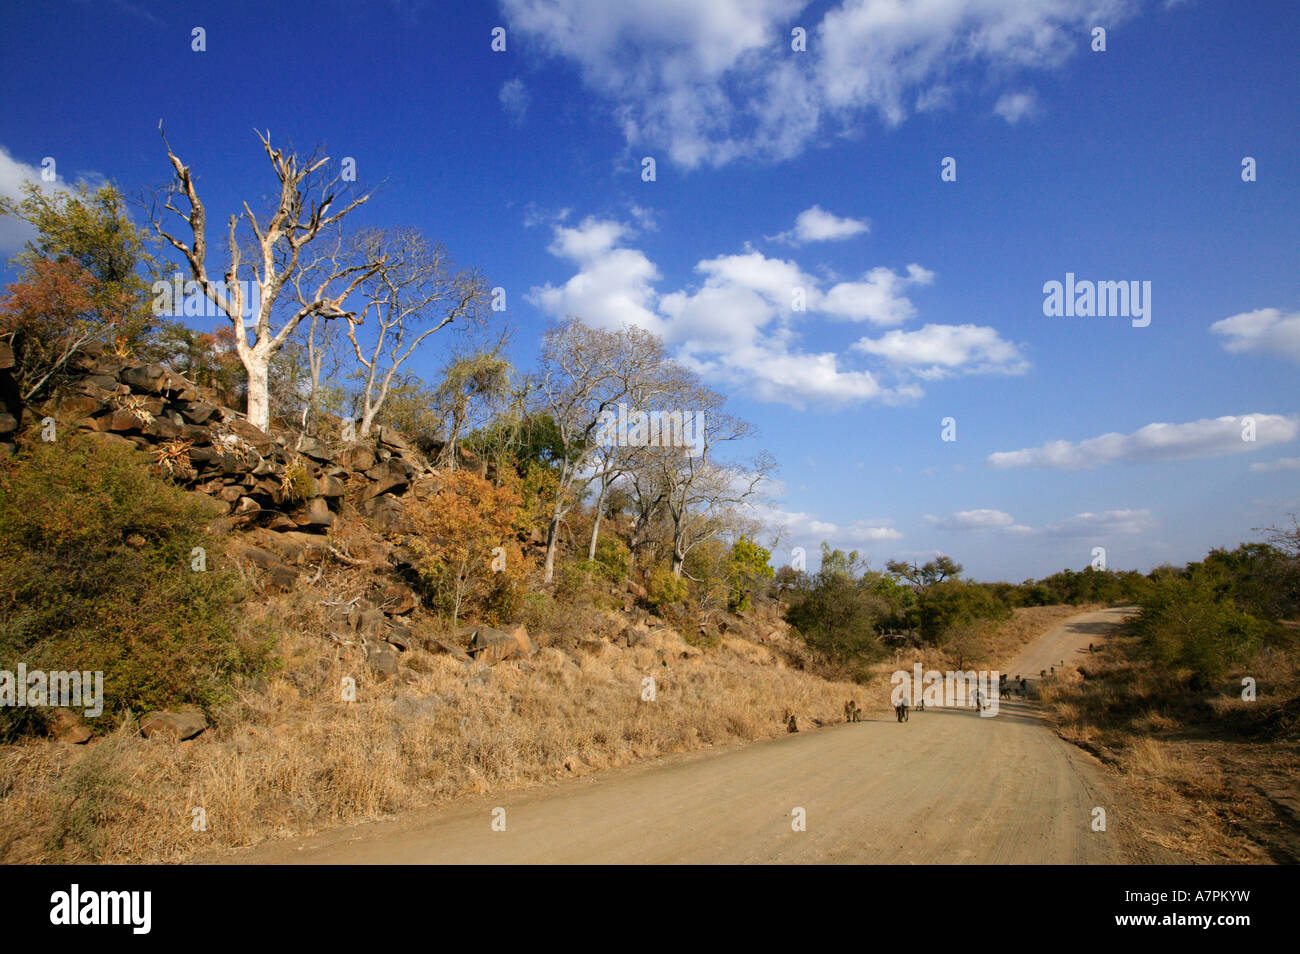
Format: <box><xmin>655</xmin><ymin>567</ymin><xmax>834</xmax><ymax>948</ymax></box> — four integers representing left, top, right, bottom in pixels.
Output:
<box><xmin>0</xmin><ymin>598</ymin><xmax>853</xmax><ymax>863</ymax></box>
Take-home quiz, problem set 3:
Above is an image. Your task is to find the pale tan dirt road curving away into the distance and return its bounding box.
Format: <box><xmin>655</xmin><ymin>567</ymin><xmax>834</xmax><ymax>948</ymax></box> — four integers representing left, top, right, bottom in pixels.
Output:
<box><xmin>229</xmin><ymin>610</ymin><xmax>1135</xmax><ymax>864</ymax></box>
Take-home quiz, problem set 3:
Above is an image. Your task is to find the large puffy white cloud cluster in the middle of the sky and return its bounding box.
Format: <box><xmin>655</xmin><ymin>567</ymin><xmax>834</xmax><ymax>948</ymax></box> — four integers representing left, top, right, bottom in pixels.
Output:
<box><xmin>528</xmin><ymin>216</ymin><xmax>1023</xmax><ymax>407</ymax></box>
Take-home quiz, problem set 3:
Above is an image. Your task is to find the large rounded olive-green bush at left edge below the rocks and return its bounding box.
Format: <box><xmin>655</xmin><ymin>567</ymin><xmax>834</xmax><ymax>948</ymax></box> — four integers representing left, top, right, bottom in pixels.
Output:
<box><xmin>0</xmin><ymin>437</ymin><xmax>269</xmax><ymax>737</ymax></box>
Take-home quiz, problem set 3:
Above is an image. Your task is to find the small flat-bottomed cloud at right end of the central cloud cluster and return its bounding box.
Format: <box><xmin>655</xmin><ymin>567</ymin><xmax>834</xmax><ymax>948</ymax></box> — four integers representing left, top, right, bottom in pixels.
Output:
<box><xmin>853</xmin><ymin>325</ymin><xmax>1030</xmax><ymax>380</ymax></box>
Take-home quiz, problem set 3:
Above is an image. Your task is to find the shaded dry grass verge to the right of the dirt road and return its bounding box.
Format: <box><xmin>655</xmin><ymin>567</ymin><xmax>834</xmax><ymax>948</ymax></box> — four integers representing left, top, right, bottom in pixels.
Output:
<box><xmin>1043</xmin><ymin>636</ymin><xmax>1300</xmax><ymax>864</ymax></box>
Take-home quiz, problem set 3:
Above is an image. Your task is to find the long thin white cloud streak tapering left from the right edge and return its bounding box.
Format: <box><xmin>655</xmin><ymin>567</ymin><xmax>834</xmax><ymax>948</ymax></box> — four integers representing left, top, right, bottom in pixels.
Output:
<box><xmin>988</xmin><ymin>415</ymin><xmax>1300</xmax><ymax>471</ymax></box>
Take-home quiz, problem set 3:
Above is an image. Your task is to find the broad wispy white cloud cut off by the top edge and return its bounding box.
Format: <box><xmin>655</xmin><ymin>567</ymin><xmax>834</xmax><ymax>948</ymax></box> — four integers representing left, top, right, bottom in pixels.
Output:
<box><xmin>502</xmin><ymin>0</ymin><xmax>1139</xmax><ymax>168</ymax></box>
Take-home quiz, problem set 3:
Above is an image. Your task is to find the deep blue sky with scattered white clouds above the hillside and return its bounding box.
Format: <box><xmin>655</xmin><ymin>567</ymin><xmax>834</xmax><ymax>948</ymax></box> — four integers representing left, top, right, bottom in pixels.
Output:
<box><xmin>0</xmin><ymin>0</ymin><xmax>1300</xmax><ymax>580</ymax></box>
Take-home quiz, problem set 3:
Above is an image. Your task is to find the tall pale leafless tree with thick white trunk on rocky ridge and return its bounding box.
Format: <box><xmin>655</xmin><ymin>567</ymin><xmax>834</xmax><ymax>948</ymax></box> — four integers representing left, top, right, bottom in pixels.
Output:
<box><xmin>151</xmin><ymin>122</ymin><xmax>382</xmax><ymax>428</ymax></box>
